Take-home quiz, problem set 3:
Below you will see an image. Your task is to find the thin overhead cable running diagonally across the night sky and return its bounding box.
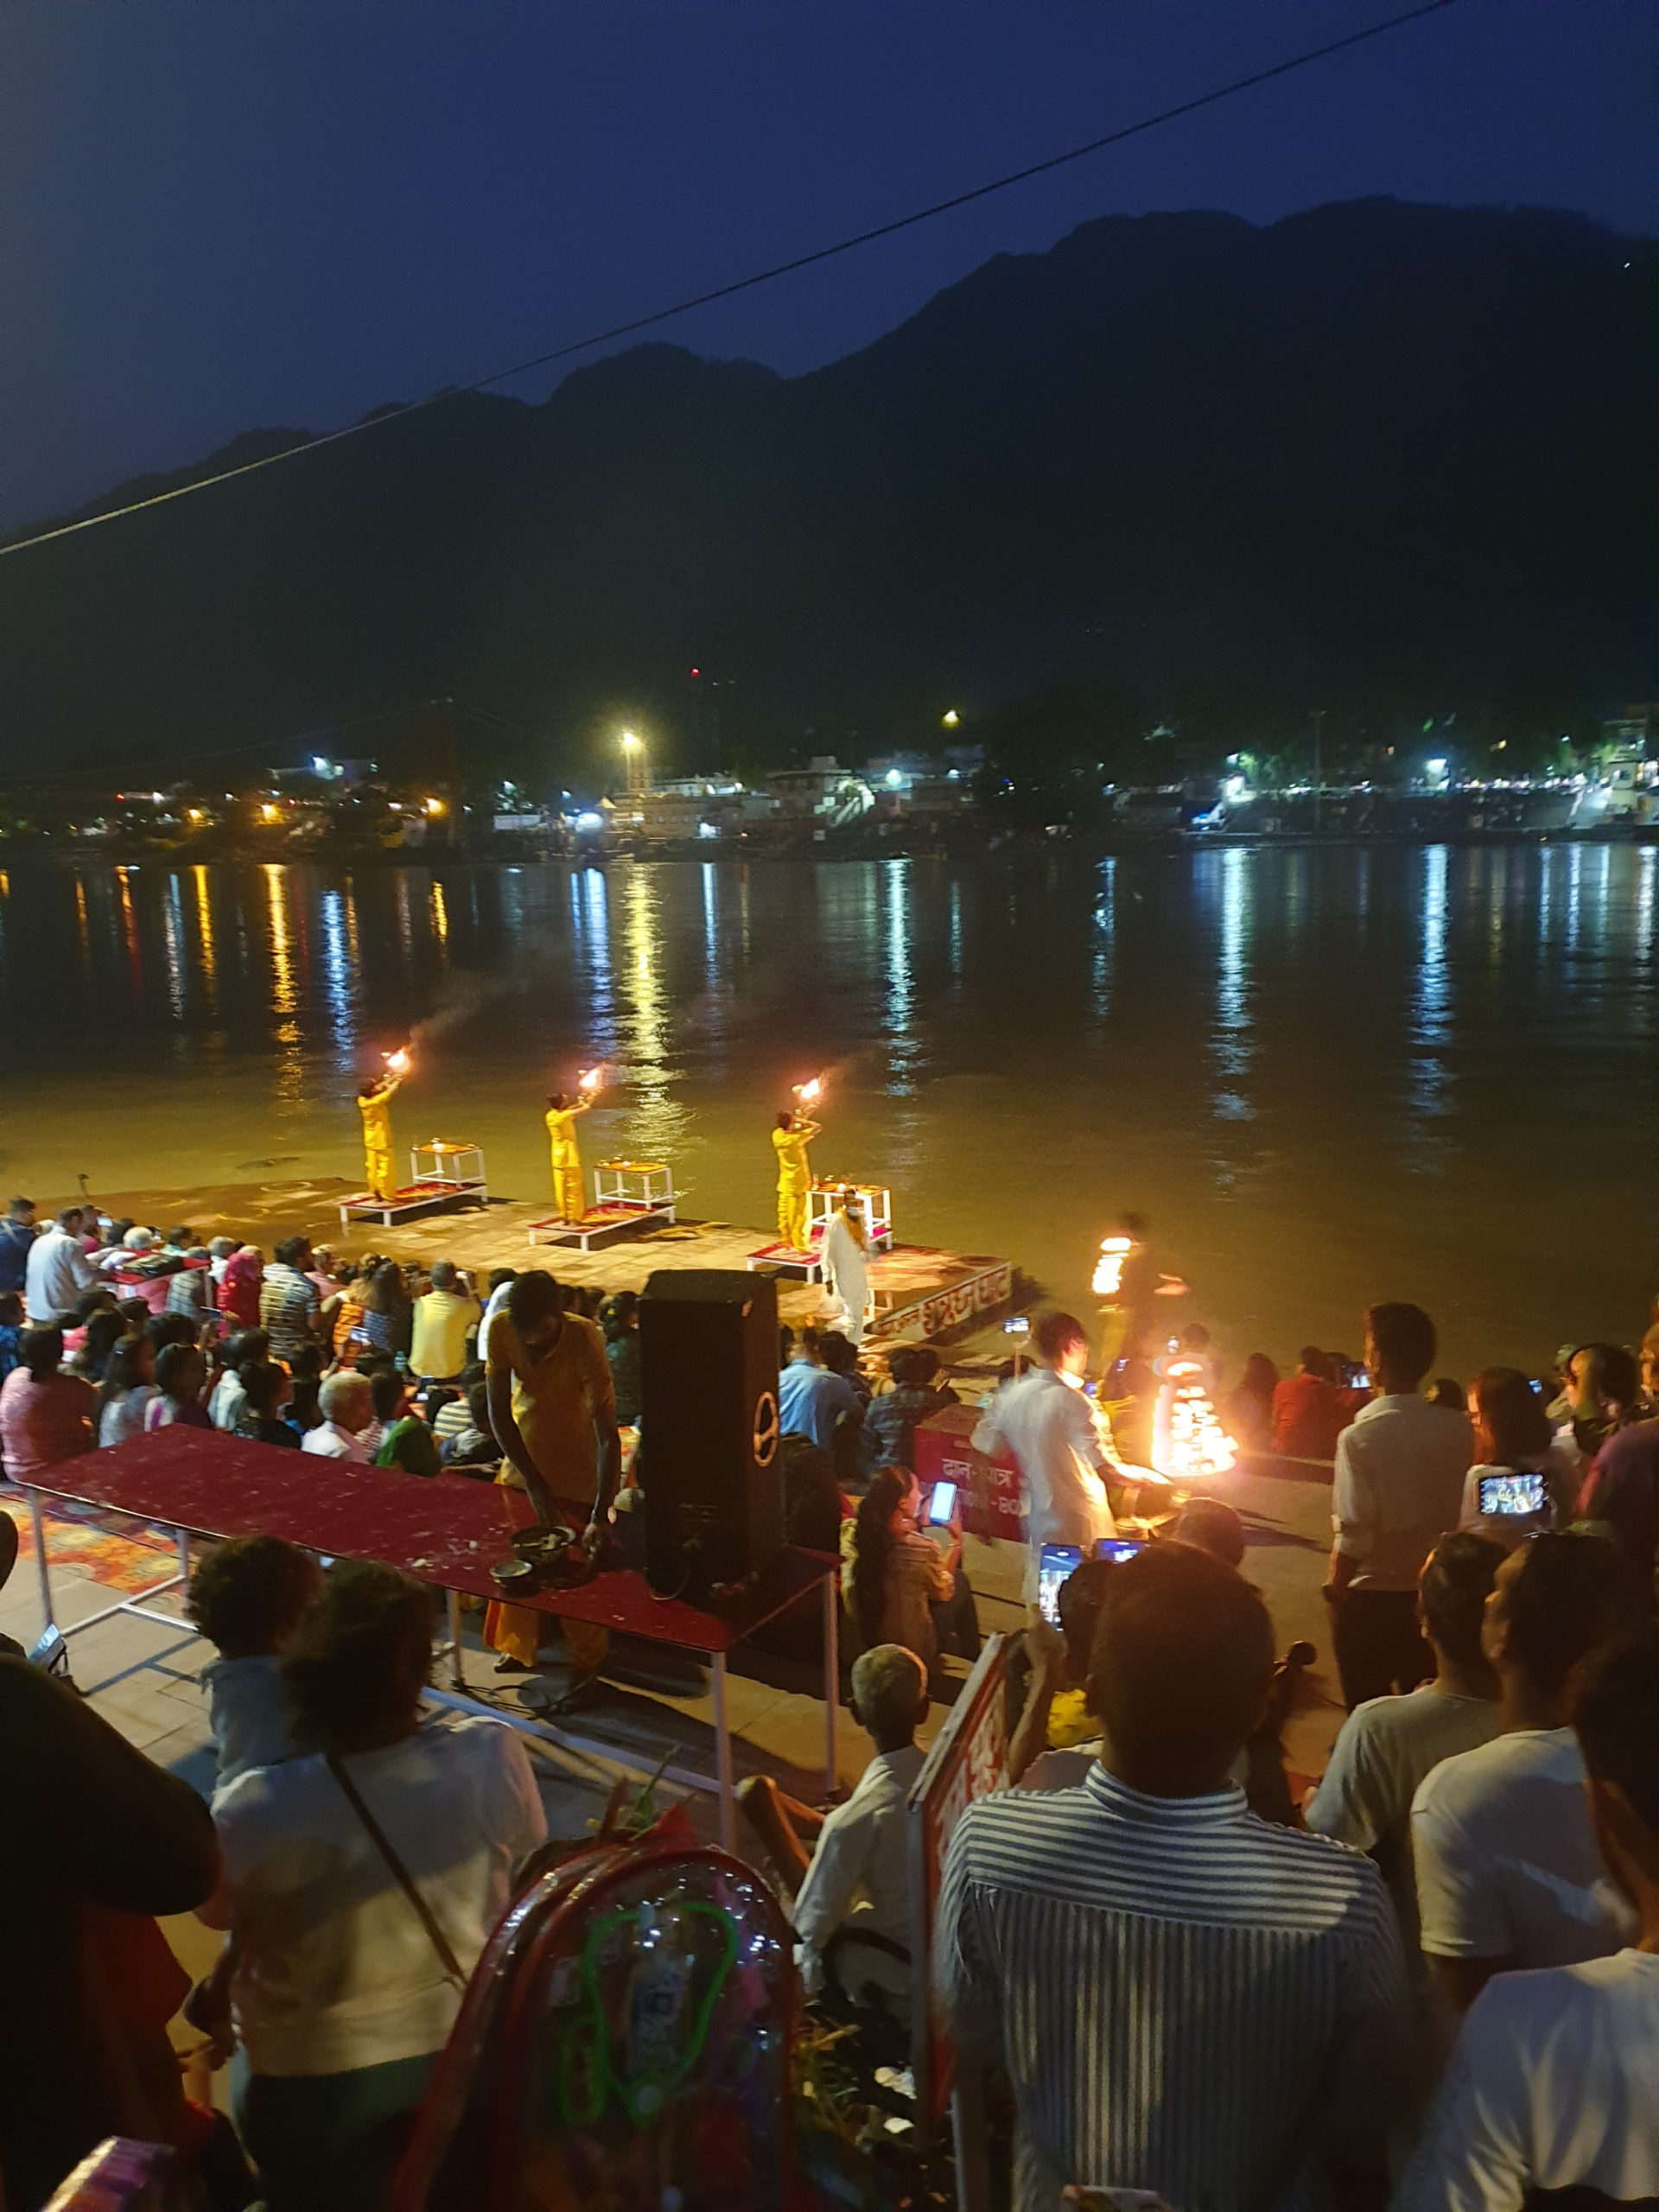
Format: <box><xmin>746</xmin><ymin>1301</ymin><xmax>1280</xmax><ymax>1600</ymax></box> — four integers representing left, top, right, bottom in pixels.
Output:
<box><xmin>0</xmin><ymin>0</ymin><xmax>1458</xmax><ymax>560</ymax></box>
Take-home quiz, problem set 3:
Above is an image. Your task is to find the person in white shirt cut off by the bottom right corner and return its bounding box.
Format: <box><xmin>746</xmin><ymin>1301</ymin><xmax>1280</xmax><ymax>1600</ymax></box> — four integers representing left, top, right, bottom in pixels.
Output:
<box><xmin>1395</xmin><ymin>1637</ymin><xmax>1659</xmax><ymax>2212</ymax></box>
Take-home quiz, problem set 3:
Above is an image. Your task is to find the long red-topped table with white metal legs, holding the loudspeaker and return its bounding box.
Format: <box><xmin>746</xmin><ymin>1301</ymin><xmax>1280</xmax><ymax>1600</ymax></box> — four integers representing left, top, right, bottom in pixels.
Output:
<box><xmin>29</xmin><ymin>1425</ymin><xmax>838</xmax><ymax>1849</ymax></box>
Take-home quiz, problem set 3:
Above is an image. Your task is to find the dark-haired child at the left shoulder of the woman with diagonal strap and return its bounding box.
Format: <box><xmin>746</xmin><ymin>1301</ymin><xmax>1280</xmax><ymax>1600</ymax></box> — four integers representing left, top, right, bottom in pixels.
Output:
<box><xmin>188</xmin><ymin>1535</ymin><xmax>323</xmax><ymax>1792</ymax></box>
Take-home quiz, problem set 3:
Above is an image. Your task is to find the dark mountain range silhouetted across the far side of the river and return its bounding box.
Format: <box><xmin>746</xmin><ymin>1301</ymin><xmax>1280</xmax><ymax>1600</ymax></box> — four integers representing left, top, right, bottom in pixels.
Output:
<box><xmin>0</xmin><ymin>201</ymin><xmax>1650</xmax><ymax>774</ymax></box>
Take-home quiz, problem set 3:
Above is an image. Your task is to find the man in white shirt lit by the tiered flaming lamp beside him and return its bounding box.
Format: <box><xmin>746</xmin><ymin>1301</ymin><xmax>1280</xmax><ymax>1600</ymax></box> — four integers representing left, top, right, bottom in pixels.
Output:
<box><xmin>973</xmin><ymin>1314</ymin><xmax>1117</xmax><ymax>1604</ymax></box>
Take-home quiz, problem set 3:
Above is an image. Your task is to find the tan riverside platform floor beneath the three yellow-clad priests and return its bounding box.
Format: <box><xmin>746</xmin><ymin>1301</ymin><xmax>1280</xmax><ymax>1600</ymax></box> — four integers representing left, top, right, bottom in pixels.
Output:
<box><xmin>93</xmin><ymin>1177</ymin><xmax>1015</xmax><ymax>1340</ymax></box>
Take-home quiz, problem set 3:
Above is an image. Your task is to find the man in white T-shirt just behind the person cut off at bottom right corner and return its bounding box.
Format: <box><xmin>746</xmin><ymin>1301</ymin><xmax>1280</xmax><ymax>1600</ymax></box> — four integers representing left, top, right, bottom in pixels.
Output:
<box><xmin>1411</xmin><ymin>1533</ymin><xmax>1635</xmax><ymax>2013</ymax></box>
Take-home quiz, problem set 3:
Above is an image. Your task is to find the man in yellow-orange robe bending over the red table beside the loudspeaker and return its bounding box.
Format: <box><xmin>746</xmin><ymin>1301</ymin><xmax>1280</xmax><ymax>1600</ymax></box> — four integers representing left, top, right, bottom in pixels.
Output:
<box><xmin>485</xmin><ymin>1269</ymin><xmax>621</xmax><ymax>1668</ymax></box>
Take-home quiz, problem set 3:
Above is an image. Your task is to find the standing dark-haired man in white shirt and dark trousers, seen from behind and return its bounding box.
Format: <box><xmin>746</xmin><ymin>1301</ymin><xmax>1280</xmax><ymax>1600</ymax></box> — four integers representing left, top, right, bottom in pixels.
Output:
<box><xmin>1325</xmin><ymin>1305</ymin><xmax>1473</xmax><ymax>1707</ymax></box>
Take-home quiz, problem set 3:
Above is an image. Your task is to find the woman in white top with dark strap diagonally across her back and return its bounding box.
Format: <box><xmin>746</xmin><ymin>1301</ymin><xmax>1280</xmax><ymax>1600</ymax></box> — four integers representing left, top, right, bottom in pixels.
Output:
<box><xmin>201</xmin><ymin>1560</ymin><xmax>546</xmax><ymax>2212</ymax></box>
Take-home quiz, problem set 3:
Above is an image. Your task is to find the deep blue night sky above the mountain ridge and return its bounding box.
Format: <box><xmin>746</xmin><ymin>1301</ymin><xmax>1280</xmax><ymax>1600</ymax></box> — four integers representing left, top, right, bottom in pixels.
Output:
<box><xmin>0</xmin><ymin>0</ymin><xmax>1652</xmax><ymax>526</ymax></box>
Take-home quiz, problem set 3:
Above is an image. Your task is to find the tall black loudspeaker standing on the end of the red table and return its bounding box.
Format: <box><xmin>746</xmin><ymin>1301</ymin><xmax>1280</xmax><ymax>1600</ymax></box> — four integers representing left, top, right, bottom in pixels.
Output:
<box><xmin>639</xmin><ymin>1268</ymin><xmax>783</xmax><ymax>1601</ymax></box>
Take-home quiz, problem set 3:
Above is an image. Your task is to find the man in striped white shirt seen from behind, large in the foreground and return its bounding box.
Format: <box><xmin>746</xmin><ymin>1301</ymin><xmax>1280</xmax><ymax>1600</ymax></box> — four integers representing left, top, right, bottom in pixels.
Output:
<box><xmin>936</xmin><ymin>1544</ymin><xmax>1409</xmax><ymax>2212</ymax></box>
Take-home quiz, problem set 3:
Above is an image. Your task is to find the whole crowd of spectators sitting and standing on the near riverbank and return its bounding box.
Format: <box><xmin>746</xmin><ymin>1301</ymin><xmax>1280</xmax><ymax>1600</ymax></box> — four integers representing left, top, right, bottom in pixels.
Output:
<box><xmin>0</xmin><ymin>1205</ymin><xmax>1659</xmax><ymax>2212</ymax></box>
